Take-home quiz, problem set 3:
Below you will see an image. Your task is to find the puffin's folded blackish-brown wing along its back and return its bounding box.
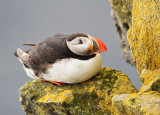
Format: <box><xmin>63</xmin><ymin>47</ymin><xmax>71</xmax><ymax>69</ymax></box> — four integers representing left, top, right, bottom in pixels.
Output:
<box><xmin>26</xmin><ymin>35</ymin><xmax>69</xmax><ymax>76</ymax></box>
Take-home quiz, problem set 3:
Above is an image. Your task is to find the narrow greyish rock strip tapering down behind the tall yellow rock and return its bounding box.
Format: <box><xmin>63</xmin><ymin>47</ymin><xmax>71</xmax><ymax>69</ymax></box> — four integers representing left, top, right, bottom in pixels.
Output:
<box><xmin>109</xmin><ymin>0</ymin><xmax>135</xmax><ymax>66</ymax></box>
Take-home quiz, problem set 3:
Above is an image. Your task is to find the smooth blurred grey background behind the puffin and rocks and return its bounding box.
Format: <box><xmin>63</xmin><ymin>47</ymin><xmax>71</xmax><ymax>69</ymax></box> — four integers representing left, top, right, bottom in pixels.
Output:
<box><xmin>0</xmin><ymin>0</ymin><xmax>141</xmax><ymax>115</ymax></box>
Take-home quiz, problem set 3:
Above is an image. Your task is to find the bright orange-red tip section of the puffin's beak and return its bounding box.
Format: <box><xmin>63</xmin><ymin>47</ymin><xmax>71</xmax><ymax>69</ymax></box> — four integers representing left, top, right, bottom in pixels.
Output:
<box><xmin>92</xmin><ymin>37</ymin><xmax>107</xmax><ymax>53</ymax></box>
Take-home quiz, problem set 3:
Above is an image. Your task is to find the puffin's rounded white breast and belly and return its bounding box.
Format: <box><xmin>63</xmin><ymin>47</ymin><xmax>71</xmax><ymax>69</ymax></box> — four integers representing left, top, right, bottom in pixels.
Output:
<box><xmin>42</xmin><ymin>54</ymin><xmax>101</xmax><ymax>83</ymax></box>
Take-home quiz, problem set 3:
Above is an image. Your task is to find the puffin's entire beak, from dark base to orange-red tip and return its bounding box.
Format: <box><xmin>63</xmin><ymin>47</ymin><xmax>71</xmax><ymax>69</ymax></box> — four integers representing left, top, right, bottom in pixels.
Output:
<box><xmin>88</xmin><ymin>35</ymin><xmax>107</xmax><ymax>54</ymax></box>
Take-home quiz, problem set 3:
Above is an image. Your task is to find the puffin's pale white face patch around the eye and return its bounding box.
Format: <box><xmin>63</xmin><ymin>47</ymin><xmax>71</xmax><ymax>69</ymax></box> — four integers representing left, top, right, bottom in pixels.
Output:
<box><xmin>66</xmin><ymin>37</ymin><xmax>93</xmax><ymax>55</ymax></box>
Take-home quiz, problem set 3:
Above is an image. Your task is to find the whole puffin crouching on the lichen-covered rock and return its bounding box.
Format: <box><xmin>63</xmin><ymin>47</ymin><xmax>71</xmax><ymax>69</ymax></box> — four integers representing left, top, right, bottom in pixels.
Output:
<box><xmin>14</xmin><ymin>33</ymin><xmax>107</xmax><ymax>85</ymax></box>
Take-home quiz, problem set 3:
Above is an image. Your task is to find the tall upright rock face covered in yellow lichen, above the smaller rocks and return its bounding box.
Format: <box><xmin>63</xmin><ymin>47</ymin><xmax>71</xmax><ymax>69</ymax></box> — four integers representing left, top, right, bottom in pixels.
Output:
<box><xmin>127</xmin><ymin>0</ymin><xmax>160</xmax><ymax>74</ymax></box>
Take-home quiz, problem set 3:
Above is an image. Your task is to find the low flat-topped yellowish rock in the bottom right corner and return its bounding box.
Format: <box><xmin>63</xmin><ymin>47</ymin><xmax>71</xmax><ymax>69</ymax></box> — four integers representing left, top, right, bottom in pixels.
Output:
<box><xmin>112</xmin><ymin>91</ymin><xmax>160</xmax><ymax>115</ymax></box>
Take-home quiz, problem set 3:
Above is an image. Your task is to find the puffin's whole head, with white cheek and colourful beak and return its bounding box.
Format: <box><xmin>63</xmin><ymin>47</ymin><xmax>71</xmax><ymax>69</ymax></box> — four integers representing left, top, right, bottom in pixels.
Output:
<box><xmin>66</xmin><ymin>33</ymin><xmax>107</xmax><ymax>56</ymax></box>
